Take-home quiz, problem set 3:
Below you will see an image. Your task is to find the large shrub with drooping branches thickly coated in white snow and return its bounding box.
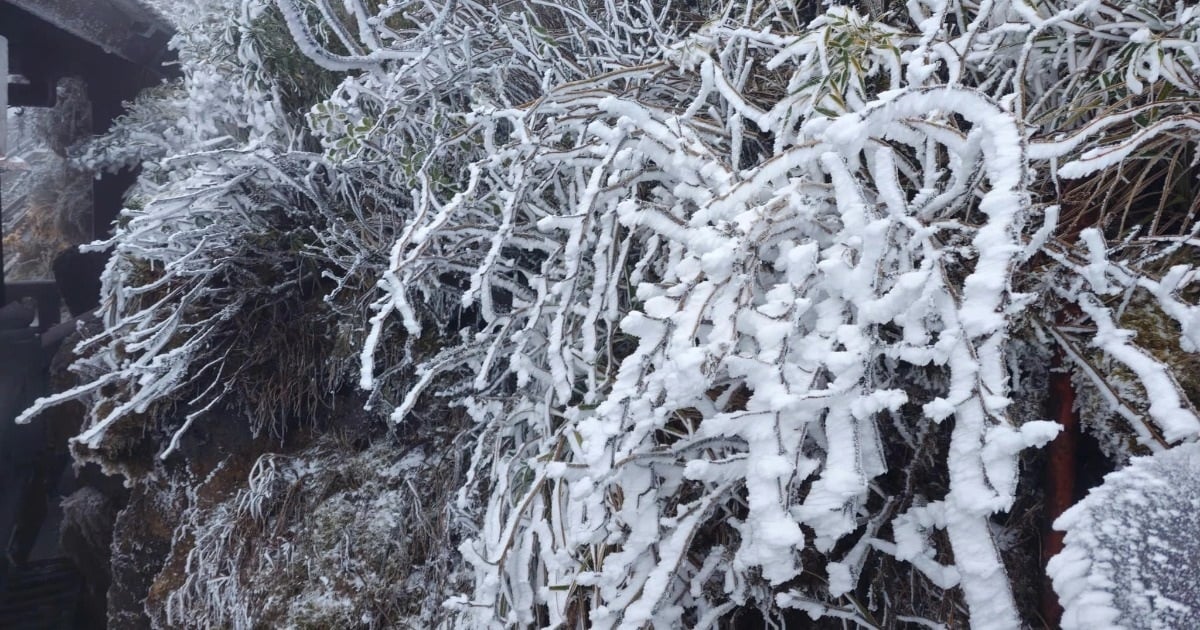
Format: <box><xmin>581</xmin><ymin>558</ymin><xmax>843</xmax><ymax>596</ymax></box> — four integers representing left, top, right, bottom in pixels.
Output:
<box><xmin>324</xmin><ymin>2</ymin><xmax>1200</xmax><ymax>628</ymax></box>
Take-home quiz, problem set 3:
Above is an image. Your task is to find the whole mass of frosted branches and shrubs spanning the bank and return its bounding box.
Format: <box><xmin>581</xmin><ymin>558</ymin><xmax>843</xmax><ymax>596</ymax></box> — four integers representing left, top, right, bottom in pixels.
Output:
<box><xmin>21</xmin><ymin>0</ymin><xmax>1200</xmax><ymax>629</ymax></box>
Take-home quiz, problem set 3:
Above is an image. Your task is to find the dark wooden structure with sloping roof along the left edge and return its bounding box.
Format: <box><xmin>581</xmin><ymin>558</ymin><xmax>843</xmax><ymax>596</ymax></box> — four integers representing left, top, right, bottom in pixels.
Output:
<box><xmin>0</xmin><ymin>0</ymin><xmax>173</xmax><ymax>628</ymax></box>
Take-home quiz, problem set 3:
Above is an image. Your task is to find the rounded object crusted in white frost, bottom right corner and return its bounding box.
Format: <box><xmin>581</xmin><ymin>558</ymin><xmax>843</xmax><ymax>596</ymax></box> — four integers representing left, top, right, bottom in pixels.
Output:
<box><xmin>1046</xmin><ymin>443</ymin><xmax>1200</xmax><ymax>630</ymax></box>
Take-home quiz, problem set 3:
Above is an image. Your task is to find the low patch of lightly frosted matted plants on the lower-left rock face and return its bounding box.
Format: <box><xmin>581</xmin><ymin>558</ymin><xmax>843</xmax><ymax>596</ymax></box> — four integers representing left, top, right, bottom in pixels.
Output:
<box><xmin>160</xmin><ymin>440</ymin><xmax>463</xmax><ymax>629</ymax></box>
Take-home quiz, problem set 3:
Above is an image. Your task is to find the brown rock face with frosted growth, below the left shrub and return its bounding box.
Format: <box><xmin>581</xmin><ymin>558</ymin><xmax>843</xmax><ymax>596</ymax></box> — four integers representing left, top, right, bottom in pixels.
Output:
<box><xmin>82</xmin><ymin>391</ymin><xmax>468</xmax><ymax>629</ymax></box>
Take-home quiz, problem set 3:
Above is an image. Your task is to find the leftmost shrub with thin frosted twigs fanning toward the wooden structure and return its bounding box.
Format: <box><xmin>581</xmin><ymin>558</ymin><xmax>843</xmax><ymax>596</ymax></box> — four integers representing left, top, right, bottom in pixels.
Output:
<box><xmin>19</xmin><ymin>2</ymin><xmax>356</xmax><ymax>473</ymax></box>
